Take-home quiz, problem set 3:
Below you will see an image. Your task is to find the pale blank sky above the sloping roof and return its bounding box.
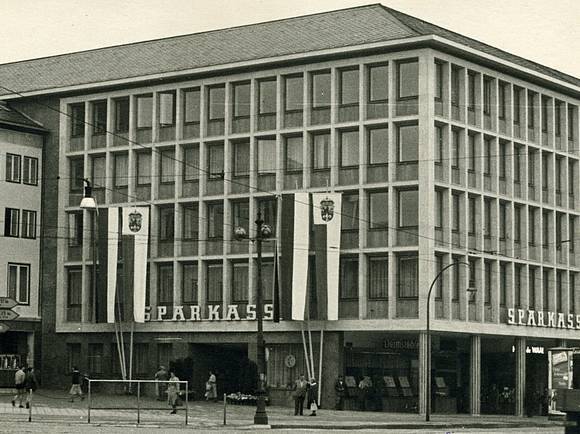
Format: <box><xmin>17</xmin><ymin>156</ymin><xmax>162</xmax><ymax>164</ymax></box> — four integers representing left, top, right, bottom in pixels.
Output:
<box><xmin>0</xmin><ymin>0</ymin><xmax>580</xmax><ymax>77</ymax></box>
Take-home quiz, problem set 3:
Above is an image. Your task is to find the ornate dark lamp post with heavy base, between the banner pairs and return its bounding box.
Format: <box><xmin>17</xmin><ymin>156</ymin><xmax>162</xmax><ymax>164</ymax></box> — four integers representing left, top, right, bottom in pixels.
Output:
<box><xmin>234</xmin><ymin>211</ymin><xmax>272</xmax><ymax>425</ymax></box>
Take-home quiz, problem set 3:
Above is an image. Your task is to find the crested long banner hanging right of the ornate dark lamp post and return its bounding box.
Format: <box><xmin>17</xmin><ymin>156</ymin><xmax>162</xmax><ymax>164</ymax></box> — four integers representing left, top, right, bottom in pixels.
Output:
<box><xmin>312</xmin><ymin>193</ymin><xmax>342</xmax><ymax>321</ymax></box>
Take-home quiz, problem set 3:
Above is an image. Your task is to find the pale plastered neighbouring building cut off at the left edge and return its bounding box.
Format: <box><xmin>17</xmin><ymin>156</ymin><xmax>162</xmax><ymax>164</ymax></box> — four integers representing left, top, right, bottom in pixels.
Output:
<box><xmin>0</xmin><ymin>103</ymin><xmax>46</xmax><ymax>387</ymax></box>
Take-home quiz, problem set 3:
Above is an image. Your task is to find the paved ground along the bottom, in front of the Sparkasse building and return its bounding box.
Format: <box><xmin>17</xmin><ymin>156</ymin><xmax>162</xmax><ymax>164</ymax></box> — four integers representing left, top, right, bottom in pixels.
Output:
<box><xmin>0</xmin><ymin>390</ymin><xmax>563</xmax><ymax>433</ymax></box>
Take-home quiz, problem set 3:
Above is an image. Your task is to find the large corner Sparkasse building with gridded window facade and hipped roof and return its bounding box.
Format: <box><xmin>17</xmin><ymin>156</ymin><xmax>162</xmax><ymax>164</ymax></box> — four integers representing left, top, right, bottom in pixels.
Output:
<box><xmin>0</xmin><ymin>5</ymin><xmax>580</xmax><ymax>414</ymax></box>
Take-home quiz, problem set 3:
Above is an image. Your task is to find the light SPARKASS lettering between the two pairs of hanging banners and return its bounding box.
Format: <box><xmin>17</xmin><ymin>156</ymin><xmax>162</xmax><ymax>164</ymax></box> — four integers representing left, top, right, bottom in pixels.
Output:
<box><xmin>145</xmin><ymin>304</ymin><xmax>274</xmax><ymax>322</ymax></box>
